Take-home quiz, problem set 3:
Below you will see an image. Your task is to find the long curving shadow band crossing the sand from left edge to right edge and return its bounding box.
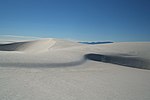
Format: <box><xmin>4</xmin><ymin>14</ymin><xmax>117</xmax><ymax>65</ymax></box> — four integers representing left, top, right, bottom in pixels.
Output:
<box><xmin>0</xmin><ymin>53</ymin><xmax>150</xmax><ymax>70</ymax></box>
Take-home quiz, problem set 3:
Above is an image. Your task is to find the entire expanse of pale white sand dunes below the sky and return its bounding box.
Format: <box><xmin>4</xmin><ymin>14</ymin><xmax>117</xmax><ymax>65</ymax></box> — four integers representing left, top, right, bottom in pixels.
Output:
<box><xmin>0</xmin><ymin>39</ymin><xmax>150</xmax><ymax>100</ymax></box>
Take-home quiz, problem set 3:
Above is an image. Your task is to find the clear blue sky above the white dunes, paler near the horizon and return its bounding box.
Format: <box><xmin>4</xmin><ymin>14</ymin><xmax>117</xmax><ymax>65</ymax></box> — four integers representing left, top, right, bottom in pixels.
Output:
<box><xmin>0</xmin><ymin>0</ymin><xmax>150</xmax><ymax>42</ymax></box>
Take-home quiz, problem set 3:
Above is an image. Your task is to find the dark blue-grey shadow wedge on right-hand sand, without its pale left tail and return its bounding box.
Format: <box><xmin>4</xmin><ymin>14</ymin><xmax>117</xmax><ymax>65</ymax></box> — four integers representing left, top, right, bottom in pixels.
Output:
<box><xmin>85</xmin><ymin>54</ymin><xmax>150</xmax><ymax>70</ymax></box>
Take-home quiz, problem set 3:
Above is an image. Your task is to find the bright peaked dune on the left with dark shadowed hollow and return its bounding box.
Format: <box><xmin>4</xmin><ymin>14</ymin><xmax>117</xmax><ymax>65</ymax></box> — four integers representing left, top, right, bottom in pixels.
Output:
<box><xmin>0</xmin><ymin>39</ymin><xmax>55</xmax><ymax>52</ymax></box>
